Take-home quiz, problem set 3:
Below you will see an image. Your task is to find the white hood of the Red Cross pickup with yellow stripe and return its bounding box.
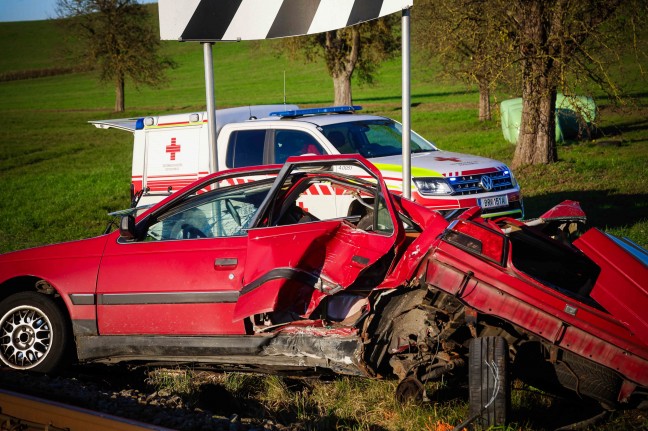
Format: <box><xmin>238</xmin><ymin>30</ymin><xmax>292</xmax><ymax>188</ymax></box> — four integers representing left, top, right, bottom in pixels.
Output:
<box><xmin>369</xmin><ymin>150</ymin><xmax>508</xmax><ymax>177</ymax></box>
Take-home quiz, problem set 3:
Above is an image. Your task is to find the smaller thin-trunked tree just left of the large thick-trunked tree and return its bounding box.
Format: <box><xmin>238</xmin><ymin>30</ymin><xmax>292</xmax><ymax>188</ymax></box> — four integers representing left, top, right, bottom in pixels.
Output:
<box><xmin>412</xmin><ymin>0</ymin><xmax>511</xmax><ymax>121</ymax></box>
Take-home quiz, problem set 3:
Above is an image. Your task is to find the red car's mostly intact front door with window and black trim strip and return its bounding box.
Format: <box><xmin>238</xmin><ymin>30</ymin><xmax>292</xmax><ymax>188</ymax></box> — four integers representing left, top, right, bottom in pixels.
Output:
<box><xmin>97</xmin><ymin>182</ymin><xmax>267</xmax><ymax>335</ymax></box>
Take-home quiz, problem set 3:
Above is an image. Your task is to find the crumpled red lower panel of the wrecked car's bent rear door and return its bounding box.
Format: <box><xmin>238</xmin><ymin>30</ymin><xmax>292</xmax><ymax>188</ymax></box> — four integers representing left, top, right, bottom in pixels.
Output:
<box><xmin>234</xmin><ymin>220</ymin><xmax>395</xmax><ymax>320</ymax></box>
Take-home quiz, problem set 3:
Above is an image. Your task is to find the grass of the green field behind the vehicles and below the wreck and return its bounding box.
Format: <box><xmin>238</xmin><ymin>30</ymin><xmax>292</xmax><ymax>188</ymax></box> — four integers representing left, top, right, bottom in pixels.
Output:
<box><xmin>0</xmin><ymin>10</ymin><xmax>648</xmax><ymax>430</ymax></box>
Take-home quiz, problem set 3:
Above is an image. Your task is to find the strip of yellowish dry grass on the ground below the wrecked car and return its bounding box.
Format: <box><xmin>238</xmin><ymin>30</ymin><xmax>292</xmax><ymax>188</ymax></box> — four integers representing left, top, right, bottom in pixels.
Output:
<box><xmin>147</xmin><ymin>368</ymin><xmax>648</xmax><ymax>431</ymax></box>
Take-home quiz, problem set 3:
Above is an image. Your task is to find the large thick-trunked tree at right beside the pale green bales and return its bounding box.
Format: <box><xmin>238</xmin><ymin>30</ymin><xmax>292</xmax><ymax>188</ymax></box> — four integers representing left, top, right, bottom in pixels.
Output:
<box><xmin>412</xmin><ymin>0</ymin><xmax>648</xmax><ymax>168</ymax></box>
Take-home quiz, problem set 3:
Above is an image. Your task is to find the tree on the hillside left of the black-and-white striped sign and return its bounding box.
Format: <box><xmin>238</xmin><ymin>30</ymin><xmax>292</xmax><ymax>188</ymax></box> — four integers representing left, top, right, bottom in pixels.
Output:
<box><xmin>57</xmin><ymin>0</ymin><xmax>174</xmax><ymax>112</ymax></box>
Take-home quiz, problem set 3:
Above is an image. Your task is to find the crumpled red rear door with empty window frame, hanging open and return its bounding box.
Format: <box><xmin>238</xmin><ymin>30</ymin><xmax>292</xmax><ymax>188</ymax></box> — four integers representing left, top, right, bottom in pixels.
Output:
<box><xmin>234</xmin><ymin>156</ymin><xmax>404</xmax><ymax>320</ymax></box>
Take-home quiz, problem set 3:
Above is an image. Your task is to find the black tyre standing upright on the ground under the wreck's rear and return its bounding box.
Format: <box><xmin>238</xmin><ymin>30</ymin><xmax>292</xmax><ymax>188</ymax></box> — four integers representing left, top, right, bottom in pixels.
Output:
<box><xmin>468</xmin><ymin>337</ymin><xmax>511</xmax><ymax>427</ymax></box>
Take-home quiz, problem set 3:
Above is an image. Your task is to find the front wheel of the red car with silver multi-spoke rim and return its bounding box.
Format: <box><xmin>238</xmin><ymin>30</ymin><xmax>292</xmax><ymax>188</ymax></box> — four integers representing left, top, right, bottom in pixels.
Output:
<box><xmin>0</xmin><ymin>292</ymin><xmax>70</xmax><ymax>373</ymax></box>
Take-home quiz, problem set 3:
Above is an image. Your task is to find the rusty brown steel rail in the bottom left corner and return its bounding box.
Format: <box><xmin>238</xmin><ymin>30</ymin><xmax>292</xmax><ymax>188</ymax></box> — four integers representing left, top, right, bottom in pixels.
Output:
<box><xmin>0</xmin><ymin>389</ymin><xmax>171</xmax><ymax>431</ymax></box>
